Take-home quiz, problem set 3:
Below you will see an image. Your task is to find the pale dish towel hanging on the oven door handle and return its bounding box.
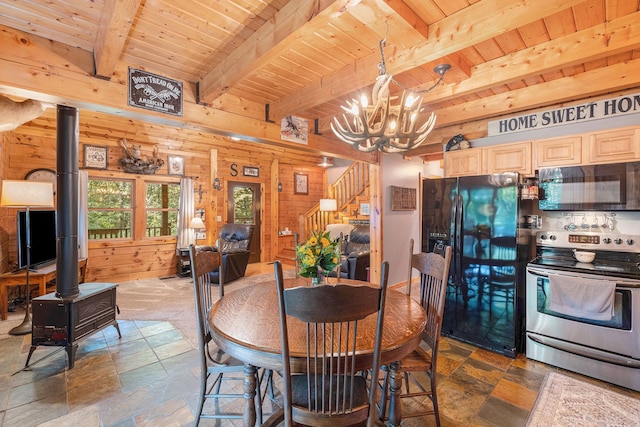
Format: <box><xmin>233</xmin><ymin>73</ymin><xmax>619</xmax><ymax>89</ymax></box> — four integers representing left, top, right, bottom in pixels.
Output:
<box><xmin>549</xmin><ymin>274</ymin><xmax>616</xmax><ymax>320</ymax></box>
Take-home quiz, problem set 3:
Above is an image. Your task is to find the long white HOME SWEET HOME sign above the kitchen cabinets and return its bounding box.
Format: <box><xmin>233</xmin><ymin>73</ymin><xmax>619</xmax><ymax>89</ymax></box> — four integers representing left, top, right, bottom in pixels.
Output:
<box><xmin>487</xmin><ymin>94</ymin><xmax>640</xmax><ymax>136</ymax></box>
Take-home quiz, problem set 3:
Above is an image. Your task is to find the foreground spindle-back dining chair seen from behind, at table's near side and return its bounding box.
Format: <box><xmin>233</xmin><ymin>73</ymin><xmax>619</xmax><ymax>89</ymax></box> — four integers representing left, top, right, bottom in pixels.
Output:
<box><xmin>266</xmin><ymin>261</ymin><xmax>389</xmax><ymax>427</ymax></box>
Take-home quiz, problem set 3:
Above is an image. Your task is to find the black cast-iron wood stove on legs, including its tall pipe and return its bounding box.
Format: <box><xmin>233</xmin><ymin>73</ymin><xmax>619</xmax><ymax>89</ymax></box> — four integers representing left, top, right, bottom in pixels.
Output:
<box><xmin>25</xmin><ymin>105</ymin><xmax>121</xmax><ymax>369</ymax></box>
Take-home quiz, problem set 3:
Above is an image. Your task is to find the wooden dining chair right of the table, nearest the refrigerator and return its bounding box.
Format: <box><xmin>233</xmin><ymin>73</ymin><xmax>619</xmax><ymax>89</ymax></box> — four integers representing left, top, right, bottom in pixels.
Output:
<box><xmin>372</xmin><ymin>239</ymin><xmax>451</xmax><ymax>426</ymax></box>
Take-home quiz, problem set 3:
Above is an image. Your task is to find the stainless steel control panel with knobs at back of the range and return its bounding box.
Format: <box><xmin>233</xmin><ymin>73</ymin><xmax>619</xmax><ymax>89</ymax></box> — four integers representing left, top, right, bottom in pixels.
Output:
<box><xmin>536</xmin><ymin>231</ymin><xmax>640</xmax><ymax>253</ymax></box>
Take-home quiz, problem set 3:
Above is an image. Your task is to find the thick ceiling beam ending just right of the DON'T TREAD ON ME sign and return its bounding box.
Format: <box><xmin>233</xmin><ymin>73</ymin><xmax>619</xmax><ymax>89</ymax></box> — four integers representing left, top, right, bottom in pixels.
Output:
<box><xmin>200</xmin><ymin>0</ymin><xmax>345</xmax><ymax>104</ymax></box>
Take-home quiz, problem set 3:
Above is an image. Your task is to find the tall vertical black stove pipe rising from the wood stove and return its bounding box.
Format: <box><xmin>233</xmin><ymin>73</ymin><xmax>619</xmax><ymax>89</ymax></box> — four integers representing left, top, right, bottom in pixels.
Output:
<box><xmin>56</xmin><ymin>105</ymin><xmax>80</xmax><ymax>298</ymax></box>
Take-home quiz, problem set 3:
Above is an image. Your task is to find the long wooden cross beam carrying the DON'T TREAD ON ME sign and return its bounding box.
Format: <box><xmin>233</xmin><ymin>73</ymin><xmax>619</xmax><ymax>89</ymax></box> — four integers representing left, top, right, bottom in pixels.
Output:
<box><xmin>0</xmin><ymin>26</ymin><xmax>378</xmax><ymax>163</ymax></box>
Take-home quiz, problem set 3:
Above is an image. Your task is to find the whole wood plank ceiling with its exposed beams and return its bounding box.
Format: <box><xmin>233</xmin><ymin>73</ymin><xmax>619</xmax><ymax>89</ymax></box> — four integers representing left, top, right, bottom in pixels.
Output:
<box><xmin>0</xmin><ymin>0</ymin><xmax>640</xmax><ymax>160</ymax></box>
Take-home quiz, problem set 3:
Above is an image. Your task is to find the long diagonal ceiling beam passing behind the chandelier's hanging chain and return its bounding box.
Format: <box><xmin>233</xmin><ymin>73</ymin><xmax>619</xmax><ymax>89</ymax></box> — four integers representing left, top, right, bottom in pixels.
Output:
<box><xmin>270</xmin><ymin>0</ymin><xmax>584</xmax><ymax>117</ymax></box>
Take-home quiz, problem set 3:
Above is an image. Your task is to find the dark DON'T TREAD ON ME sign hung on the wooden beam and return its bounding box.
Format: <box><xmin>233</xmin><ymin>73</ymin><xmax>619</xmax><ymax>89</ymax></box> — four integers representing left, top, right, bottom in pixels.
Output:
<box><xmin>129</xmin><ymin>67</ymin><xmax>182</xmax><ymax>116</ymax></box>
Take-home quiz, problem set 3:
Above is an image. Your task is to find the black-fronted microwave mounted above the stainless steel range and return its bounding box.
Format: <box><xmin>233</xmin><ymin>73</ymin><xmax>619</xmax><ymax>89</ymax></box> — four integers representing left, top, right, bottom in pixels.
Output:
<box><xmin>538</xmin><ymin>162</ymin><xmax>640</xmax><ymax>211</ymax></box>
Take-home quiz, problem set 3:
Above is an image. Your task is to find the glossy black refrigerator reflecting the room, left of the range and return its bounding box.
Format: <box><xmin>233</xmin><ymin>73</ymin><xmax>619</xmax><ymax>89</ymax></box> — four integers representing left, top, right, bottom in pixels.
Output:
<box><xmin>422</xmin><ymin>173</ymin><xmax>533</xmax><ymax>357</ymax></box>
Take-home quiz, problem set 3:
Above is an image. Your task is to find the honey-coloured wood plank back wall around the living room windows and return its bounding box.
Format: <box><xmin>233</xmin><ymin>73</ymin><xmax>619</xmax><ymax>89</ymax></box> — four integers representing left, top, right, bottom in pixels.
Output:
<box><xmin>0</xmin><ymin>109</ymin><xmax>325</xmax><ymax>282</ymax></box>
